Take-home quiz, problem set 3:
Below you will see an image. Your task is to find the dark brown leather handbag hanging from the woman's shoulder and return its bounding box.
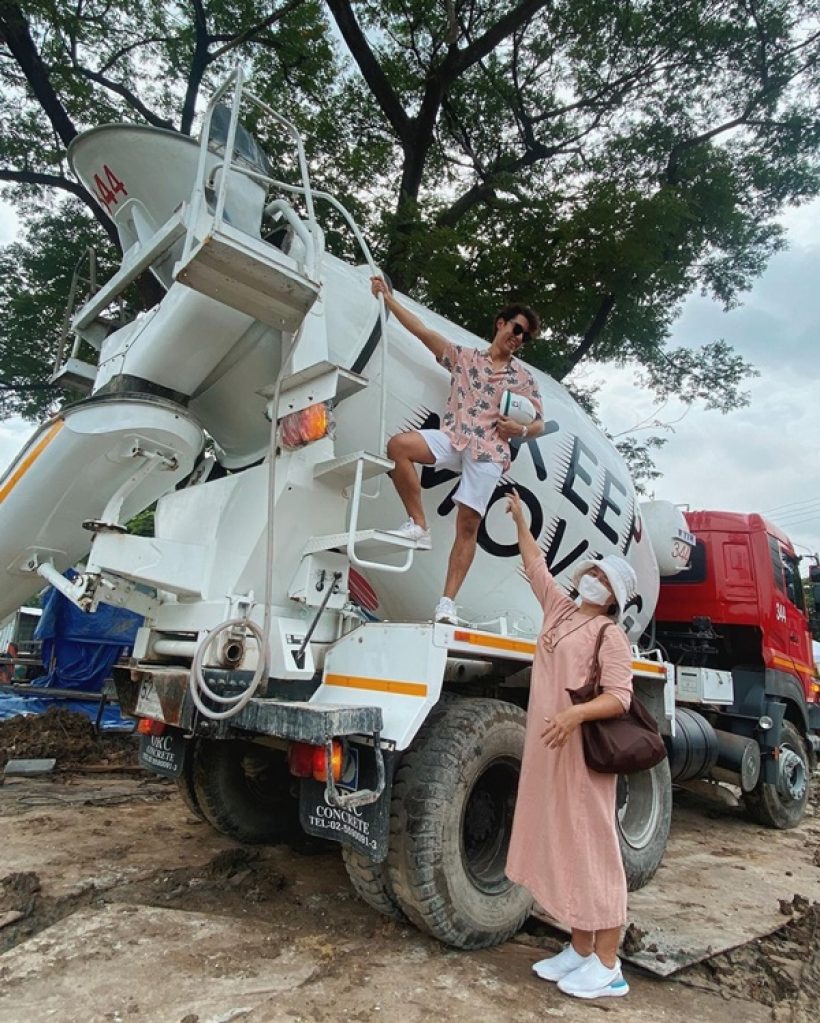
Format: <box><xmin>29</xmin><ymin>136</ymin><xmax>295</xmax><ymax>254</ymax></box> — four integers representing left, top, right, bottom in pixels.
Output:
<box><xmin>566</xmin><ymin>622</ymin><xmax>667</xmax><ymax>774</ymax></box>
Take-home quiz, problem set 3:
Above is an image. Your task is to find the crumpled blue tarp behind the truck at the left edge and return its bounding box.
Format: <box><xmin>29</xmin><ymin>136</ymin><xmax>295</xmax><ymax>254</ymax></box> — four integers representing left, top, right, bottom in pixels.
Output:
<box><xmin>0</xmin><ymin>569</ymin><xmax>142</xmax><ymax>730</ymax></box>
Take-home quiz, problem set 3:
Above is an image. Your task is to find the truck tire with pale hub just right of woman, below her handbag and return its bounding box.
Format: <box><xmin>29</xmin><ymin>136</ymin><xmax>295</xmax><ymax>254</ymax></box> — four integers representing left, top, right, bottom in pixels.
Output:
<box><xmin>616</xmin><ymin>758</ymin><xmax>672</xmax><ymax>892</ymax></box>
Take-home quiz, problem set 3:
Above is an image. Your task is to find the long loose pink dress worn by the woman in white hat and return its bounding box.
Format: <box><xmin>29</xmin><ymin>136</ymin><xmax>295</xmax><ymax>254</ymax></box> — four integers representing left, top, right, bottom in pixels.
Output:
<box><xmin>506</xmin><ymin>558</ymin><xmax>632</xmax><ymax>931</ymax></box>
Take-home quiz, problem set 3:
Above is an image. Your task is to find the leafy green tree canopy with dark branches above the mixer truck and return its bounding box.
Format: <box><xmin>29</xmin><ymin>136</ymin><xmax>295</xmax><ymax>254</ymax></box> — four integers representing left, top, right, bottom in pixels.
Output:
<box><xmin>0</xmin><ymin>0</ymin><xmax>820</xmax><ymax>462</ymax></box>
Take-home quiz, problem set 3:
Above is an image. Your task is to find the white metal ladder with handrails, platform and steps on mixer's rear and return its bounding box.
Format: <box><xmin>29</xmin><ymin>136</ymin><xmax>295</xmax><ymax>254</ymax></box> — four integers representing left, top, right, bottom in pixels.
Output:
<box><xmin>176</xmin><ymin>70</ymin><xmax>415</xmax><ymax>589</ymax></box>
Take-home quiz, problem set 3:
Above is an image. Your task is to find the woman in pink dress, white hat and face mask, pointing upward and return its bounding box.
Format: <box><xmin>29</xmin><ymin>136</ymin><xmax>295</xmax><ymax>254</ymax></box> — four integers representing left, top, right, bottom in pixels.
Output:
<box><xmin>506</xmin><ymin>492</ymin><xmax>637</xmax><ymax>998</ymax></box>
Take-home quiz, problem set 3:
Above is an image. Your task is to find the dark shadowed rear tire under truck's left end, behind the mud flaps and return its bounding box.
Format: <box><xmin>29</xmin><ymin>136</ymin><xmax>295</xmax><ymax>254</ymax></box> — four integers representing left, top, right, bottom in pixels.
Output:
<box><xmin>193</xmin><ymin>739</ymin><xmax>299</xmax><ymax>845</ymax></box>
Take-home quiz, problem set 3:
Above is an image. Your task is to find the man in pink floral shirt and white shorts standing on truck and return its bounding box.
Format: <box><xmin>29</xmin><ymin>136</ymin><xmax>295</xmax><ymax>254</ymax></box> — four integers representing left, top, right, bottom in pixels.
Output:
<box><xmin>371</xmin><ymin>277</ymin><xmax>544</xmax><ymax>624</ymax></box>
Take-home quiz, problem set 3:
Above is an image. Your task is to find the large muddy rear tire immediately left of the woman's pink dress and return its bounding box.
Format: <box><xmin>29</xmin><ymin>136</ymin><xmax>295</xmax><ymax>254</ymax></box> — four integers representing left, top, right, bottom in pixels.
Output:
<box><xmin>388</xmin><ymin>699</ymin><xmax>533</xmax><ymax>948</ymax></box>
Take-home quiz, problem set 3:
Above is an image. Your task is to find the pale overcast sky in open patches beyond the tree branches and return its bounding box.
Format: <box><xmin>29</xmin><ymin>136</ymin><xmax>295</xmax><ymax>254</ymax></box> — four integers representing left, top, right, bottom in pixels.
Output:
<box><xmin>0</xmin><ymin>202</ymin><xmax>820</xmax><ymax>574</ymax></box>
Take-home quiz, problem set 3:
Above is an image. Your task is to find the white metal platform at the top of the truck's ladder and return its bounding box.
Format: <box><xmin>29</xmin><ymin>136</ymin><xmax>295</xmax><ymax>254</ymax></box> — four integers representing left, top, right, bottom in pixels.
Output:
<box><xmin>175</xmin><ymin>223</ymin><xmax>319</xmax><ymax>333</ymax></box>
